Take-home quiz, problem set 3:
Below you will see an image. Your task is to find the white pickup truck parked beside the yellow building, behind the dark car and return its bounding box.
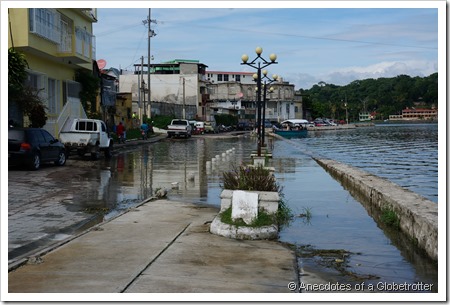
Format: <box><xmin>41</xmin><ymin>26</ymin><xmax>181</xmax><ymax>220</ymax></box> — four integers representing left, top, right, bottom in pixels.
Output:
<box><xmin>59</xmin><ymin>119</ymin><xmax>113</xmax><ymax>160</ymax></box>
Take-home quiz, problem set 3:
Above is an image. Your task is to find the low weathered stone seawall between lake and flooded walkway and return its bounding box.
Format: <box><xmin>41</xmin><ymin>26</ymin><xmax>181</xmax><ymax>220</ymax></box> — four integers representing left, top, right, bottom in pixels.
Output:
<box><xmin>314</xmin><ymin>158</ymin><xmax>438</xmax><ymax>261</ymax></box>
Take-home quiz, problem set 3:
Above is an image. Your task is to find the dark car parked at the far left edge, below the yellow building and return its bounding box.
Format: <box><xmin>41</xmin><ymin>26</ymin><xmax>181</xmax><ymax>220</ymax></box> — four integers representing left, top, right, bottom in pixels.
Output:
<box><xmin>8</xmin><ymin>128</ymin><xmax>66</xmax><ymax>170</ymax></box>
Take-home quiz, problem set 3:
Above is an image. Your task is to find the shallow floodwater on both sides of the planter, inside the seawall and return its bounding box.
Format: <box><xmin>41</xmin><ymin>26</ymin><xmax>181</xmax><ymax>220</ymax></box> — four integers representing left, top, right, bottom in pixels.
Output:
<box><xmin>73</xmin><ymin>131</ymin><xmax>437</xmax><ymax>287</ymax></box>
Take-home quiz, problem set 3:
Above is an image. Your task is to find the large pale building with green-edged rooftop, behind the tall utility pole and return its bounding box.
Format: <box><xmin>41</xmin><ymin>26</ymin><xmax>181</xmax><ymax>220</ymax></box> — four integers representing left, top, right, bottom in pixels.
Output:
<box><xmin>119</xmin><ymin>59</ymin><xmax>207</xmax><ymax>119</ymax></box>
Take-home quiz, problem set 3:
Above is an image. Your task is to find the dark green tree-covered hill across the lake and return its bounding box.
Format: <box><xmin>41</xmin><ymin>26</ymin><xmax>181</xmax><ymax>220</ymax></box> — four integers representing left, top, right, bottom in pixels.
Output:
<box><xmin>300</xmin><ymin>73</ymin><xmax>438</xmax><ymax>121</ymax></box>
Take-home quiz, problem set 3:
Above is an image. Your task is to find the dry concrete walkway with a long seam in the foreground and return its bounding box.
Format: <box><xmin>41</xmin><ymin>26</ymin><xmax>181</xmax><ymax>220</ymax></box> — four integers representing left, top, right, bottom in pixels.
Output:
<box><xmin>8</xmin><ymin>200</ymin><xmax>299</xmax><ymax>293</ymax></box>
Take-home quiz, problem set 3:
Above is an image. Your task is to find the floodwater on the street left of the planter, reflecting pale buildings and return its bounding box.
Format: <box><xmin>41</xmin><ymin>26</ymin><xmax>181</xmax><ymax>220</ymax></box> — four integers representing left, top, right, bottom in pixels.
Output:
<box><xmin>81</xmin><ymin>137</ymin><xmax>256</xmax><ymax>219</ymax></box>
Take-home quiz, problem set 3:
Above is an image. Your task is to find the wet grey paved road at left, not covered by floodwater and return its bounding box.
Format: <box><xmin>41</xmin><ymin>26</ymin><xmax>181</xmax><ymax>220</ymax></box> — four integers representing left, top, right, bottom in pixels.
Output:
<box><xmin>8</xmin><ymin>135</ymin><xmax>165</xmax><ymax>266</ymax></box>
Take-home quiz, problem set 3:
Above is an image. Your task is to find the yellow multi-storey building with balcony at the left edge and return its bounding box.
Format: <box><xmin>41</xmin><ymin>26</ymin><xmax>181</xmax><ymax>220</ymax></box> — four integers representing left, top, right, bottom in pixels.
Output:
<box><xmin>8</xmin><ymin>8</ymin><xmax>97</xmax><ymax>136</ymax></box>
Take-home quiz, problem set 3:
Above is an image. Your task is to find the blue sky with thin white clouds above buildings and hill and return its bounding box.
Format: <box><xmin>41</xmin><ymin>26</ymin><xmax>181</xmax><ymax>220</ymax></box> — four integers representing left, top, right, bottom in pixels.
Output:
<box><xmin>94</xmin><ymin>1</ymin><xmax>445</xmax><ymax>89</ymax></box>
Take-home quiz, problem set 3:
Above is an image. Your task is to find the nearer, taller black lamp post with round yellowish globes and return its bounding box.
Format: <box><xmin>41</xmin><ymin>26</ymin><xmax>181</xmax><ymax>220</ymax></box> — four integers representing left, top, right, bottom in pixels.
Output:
<box><xmin>241</xmin><ymin>47</ymin><xmax>277</xmax><ymax>157</ymax></box>
